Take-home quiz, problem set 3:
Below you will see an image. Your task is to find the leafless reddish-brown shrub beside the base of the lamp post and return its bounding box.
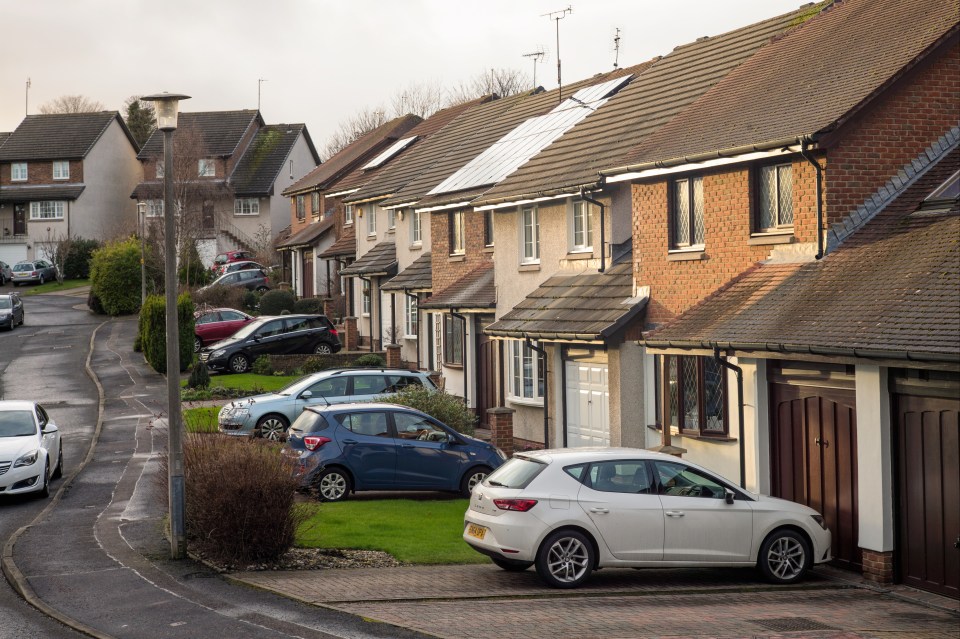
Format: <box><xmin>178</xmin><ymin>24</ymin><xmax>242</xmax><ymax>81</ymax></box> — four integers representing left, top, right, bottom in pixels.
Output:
<box><xmin>183</xmin><ymin>434</ymin><xmax>305</xmax><ymax>567</ymax></box>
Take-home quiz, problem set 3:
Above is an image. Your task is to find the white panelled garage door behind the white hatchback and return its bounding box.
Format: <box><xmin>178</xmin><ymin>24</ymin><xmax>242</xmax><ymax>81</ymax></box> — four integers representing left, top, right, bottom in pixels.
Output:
<box><xmin>564</xmin><ymin>361</ymin><xmax>610</xmax><ymax>448</ymax></box>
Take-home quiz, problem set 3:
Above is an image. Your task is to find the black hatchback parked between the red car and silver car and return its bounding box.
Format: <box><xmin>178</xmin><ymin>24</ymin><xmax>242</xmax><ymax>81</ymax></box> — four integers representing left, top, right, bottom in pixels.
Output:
<box><xmin>199</xmin><ymin>312</ymin><xmax>340</xmax><ymax>373</ymax></box>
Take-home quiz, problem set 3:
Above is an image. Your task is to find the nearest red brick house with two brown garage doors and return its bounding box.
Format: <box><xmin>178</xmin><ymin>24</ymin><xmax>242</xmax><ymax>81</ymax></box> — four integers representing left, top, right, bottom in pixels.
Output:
<box><xmin>601</xmin><ymin>0</ymin><xmax>960</xmax><ymax>596</ymax></box>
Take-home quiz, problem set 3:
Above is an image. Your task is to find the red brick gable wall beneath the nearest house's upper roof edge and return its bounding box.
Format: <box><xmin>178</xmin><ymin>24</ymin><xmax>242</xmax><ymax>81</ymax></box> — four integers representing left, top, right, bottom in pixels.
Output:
<box><xmin>824</xmin><ymin>44</ymin><xmax>960</xmax><ymax>223</ymax></box>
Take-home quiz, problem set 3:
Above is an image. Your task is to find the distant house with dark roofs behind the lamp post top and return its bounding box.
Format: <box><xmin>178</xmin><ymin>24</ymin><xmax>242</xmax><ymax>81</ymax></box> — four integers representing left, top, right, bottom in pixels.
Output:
<box><xmin>131</xmin><ymin>110</ymin><xmax>320</xmax><ymax>263</ymax></box>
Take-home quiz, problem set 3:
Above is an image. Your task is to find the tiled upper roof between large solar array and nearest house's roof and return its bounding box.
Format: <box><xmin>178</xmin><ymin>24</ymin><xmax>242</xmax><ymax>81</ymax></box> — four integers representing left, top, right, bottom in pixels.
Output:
<box><xmin>474</xmin><ymin>9</ymin><xmax>809</xmax><ymax>205</ymax></box>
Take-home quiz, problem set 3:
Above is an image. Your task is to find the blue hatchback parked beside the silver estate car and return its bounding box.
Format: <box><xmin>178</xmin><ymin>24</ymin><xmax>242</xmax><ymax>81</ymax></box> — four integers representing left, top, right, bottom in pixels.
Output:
<box><xmin>282</xmin><ymin>403</ymin><xmax>505</xmax><ymax>501</ymax></box>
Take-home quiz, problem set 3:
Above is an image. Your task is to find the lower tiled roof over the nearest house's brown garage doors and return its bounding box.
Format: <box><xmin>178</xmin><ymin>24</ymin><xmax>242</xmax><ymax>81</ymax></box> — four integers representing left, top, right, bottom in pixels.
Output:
<box><xmin>647</xmin><ymin>147</ymin><xmax>960</xmax><ymax>363</ymax></box>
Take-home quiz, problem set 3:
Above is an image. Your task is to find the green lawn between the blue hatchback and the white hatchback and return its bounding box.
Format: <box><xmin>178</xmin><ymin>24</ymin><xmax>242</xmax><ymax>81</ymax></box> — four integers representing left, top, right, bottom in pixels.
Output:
<box><xmin>296</xmin><ymin>497</ymin><xmax>489</xmax><ymax>564</ymax></box>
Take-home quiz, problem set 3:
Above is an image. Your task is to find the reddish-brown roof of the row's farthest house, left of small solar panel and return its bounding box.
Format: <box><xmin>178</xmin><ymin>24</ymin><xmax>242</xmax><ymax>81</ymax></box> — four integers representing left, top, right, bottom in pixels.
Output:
<box><xmin>283</xmin><ymin>115</ymin><xmax>423</xmax><ymax>195</ymax></box>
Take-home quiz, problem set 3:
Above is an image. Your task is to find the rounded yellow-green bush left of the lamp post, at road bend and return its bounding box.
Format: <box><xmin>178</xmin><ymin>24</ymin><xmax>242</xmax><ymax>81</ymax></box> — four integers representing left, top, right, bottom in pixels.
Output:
<box><xmin>90</xmin><ymin>239</ymin><xmax>140</xmax><ymax>316</ymax></box>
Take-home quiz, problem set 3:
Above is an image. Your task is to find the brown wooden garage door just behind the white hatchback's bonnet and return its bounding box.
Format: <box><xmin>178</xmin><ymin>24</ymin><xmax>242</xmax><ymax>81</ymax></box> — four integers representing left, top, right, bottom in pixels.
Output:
<box><xmin>770</xmin><ymin>365</ymin><xmax>863</xmax><ymax>570</ymax></box>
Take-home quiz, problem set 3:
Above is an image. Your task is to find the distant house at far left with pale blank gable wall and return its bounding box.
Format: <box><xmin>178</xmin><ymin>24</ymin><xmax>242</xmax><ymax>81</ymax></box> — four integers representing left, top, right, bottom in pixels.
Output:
<box><xmin>0</xmin><ymin>111</ymin><xmax>142</xmax><ymax>264</ymax></box>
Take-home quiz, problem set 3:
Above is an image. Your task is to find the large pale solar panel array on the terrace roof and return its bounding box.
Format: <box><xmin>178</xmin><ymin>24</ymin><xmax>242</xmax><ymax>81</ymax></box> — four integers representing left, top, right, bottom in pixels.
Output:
<box><xmin>428</xmin><ymin>75</ymin><xmax>633</xmax><ymax>195</ymax></box>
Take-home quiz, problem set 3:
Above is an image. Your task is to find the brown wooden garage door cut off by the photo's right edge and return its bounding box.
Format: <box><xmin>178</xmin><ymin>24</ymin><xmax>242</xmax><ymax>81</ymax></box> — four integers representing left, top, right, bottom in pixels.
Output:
<box><xmin>894</xmin><ymin>393</ymin><xmax>960</xmax><ymax>599</ymax></box>
